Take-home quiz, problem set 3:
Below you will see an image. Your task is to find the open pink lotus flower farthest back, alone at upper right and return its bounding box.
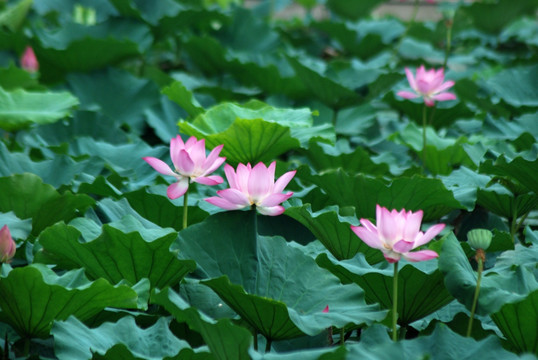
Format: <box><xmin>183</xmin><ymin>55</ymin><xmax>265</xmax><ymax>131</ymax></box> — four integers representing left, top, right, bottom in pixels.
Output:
<box><xmin>396</xmin><ymin>65</ymin><xmax>456</xmax><ymax>106</ymax></box>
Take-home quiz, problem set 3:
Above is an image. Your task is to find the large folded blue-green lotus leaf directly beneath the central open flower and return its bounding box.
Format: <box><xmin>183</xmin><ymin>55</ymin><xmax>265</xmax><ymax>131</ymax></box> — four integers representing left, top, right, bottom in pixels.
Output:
<box><xmin>177</xmin><ymin>211</ymin><xmax>386</xmax><ymax>340</ymax></box>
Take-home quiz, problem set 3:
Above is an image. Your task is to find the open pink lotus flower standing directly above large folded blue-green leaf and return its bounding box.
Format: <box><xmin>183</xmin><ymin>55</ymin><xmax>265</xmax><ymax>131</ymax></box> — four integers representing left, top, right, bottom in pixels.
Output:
<box><xmin>205</xmin><ymin>161</ymin><xmax>295</xmax><ymax>216</ymax></box>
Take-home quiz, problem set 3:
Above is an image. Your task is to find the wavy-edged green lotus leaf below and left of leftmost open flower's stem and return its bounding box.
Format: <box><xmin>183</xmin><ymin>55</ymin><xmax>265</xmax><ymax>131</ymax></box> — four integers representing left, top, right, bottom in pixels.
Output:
<box><xmin>36</xmin><ymin>217</ymin><xmax>196</xmax><ymax>289</ymax></box>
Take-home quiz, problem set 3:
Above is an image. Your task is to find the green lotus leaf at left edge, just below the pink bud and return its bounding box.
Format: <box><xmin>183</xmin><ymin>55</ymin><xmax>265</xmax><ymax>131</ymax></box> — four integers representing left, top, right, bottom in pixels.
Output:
<box><xmin>0</xmin><ymin>264</ymin><xmax>138</xmax><ymax>338</ymax></box>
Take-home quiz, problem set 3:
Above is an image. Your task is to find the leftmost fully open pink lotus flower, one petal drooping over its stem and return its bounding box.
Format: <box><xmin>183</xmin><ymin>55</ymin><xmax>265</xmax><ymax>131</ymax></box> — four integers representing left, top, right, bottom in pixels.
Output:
<box><xmin>143</xmin><ymin>135</ymin><xmax>226</xmax><ymax>199</ymax></box>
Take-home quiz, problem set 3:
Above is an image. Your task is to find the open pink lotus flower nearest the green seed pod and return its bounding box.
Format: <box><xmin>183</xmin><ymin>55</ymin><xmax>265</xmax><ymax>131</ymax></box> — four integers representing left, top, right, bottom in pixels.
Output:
<box><xmin>351</xmin><ymin>205</ymin><xmax>445</xmax><ymax>263</ymax></box>
